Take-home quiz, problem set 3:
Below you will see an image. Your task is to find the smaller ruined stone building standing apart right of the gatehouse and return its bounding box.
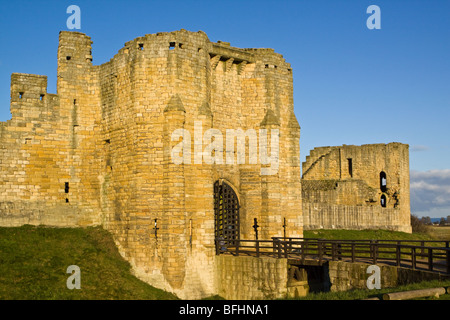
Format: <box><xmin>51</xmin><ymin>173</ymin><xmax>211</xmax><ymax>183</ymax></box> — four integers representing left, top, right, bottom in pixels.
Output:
<box><xmin>302</xmin><ymin>143</ymin><xmax>411</xmax><ymax>232</ymax></box>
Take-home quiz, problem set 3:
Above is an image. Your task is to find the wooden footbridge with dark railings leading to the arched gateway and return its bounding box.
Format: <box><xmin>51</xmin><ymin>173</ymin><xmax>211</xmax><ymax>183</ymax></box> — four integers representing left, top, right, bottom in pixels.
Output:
<box><xmin>216</xmin><ymin>237</ymin><xmax>450</xmax><ymax>276</ymax></box>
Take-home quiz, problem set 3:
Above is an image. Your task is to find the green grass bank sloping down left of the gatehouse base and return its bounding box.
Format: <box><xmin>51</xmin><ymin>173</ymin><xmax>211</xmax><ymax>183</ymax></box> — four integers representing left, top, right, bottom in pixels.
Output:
<box><xmin>0</xmin><ymin>226</ymin><xmax>177</xmax><ymax>300</ymax></box>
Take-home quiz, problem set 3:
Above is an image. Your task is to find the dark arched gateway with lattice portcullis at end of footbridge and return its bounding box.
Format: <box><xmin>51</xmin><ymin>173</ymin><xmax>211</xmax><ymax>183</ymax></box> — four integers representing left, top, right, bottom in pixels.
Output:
<box><xmin>214</xmin><ymin>181</ymin><xmax>240</xmax><ymax>244</ymax></box>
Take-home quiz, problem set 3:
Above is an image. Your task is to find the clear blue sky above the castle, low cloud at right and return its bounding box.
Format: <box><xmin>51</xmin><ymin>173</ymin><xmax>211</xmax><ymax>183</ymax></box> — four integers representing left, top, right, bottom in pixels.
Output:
<box><xmin>0</xmin><ymin>0</ymin><xmax>450</xmax><ymax>216</ymax></box>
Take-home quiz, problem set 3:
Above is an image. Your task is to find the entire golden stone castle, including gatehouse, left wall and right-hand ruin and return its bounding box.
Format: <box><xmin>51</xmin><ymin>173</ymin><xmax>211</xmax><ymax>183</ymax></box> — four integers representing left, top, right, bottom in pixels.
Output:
<box><xmin>0</xmin><ymin>30</ymin><xmax>409</xmax><ymax>299</ymax></box>
